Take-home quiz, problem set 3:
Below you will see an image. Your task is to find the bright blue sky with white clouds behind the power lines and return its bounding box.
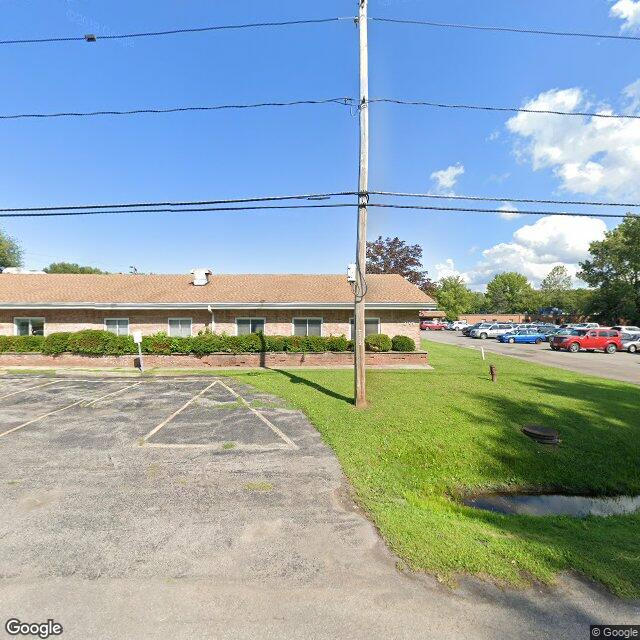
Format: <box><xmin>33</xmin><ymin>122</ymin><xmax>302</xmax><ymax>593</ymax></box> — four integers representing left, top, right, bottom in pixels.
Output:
<box><xmin>0</xmin><ymin>0</ymin><xmax>640</xmax><ymax>288</ymax></box>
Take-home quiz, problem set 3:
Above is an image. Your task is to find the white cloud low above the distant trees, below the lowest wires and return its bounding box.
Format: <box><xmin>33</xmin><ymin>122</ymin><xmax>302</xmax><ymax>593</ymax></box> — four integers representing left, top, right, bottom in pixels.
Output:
<box><xmin>461</xmin><ymin>216</ymin><xmax>607</xmax><ymax>289</ymax></box>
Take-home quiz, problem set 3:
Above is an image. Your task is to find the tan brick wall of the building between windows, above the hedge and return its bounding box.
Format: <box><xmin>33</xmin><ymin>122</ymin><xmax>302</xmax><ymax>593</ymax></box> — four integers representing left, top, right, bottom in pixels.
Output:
<box><xmin>0</xmin><ymin>309</ymin><xmax>420</xmax><ymax>345</ymax></box>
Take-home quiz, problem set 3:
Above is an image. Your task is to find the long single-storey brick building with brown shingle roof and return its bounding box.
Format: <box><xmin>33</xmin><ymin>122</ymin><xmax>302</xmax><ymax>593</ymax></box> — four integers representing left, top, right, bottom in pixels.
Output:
<box><xmin>0</xmin><ymin>270</ymin><xmax>436</xmax><ymax>344</ymax></box>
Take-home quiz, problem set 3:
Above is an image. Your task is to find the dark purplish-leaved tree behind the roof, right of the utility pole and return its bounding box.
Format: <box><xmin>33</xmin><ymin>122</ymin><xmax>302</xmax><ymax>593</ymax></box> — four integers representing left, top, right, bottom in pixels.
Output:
<box><xmin>367</xmin><ymin>236</ymin><xmax>435</xmax><ymax>295</ymax></box>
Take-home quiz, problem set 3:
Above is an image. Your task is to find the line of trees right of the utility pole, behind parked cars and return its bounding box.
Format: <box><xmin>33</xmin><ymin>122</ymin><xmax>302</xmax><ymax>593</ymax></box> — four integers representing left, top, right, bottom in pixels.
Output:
<box><xmin>367</xmin><ymin>216</ymin><xmax>640</xmax><ymax>324</ymax></box>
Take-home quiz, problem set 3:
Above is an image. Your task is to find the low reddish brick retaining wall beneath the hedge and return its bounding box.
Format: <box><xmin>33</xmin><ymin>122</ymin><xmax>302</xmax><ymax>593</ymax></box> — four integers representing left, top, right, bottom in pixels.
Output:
<box><xmin>0</xmin><ymin>351</ymin><xmax>429</xmax><ymax>369</ymax></box>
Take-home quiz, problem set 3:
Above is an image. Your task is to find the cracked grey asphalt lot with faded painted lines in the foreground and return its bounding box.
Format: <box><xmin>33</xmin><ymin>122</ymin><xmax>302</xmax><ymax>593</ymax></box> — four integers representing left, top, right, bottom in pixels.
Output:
<box><xmin>0</xmin><ymin>376</ymin><xmax>640</xmax><ymax>640</ymax></box>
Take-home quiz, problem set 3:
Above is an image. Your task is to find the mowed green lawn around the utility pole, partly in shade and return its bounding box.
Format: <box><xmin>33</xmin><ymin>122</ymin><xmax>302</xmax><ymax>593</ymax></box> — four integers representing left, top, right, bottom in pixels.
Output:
<box><xmin>229</xmin><ymin>343</ymin><xmax>640</xmax><ymax>598</ymax></box>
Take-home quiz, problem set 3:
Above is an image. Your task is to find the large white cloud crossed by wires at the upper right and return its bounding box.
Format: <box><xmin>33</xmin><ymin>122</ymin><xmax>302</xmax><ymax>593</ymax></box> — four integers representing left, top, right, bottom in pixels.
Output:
<box><xmin>507</xmin><ymin>82</ymin><xmax>640</xmax><ymax>199</ymax></box>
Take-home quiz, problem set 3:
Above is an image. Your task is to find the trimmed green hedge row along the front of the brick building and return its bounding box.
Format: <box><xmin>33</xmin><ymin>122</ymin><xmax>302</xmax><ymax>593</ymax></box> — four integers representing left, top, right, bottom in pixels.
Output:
<box><xmin>0</xmin><ymin>330</ymin><xmax>416</xmax><ymax>356</ymax></box>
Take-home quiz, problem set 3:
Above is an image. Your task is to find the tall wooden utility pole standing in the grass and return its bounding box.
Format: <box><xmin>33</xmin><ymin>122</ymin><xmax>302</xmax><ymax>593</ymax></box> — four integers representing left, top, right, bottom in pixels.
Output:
<box><xmin>354</xmin><ymin>0</ymin><xmax>369</xmax><ymax>407</ymax></box>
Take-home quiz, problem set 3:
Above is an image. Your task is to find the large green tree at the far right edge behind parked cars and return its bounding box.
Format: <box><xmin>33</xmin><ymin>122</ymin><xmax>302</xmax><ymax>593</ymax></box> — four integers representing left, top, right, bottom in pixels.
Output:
<box><xmin>578</xmin><ymin>216</ymin><xmax>640</xmax><ymax>324</ymax></box>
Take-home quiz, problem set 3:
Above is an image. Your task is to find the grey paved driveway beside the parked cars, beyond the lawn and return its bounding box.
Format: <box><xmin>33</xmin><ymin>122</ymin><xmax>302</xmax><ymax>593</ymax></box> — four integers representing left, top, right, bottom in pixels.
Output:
<box><xmin>421</xmin><ymin>331</ymin><xmax>640</xmax><ymax>384</ymax></box>
